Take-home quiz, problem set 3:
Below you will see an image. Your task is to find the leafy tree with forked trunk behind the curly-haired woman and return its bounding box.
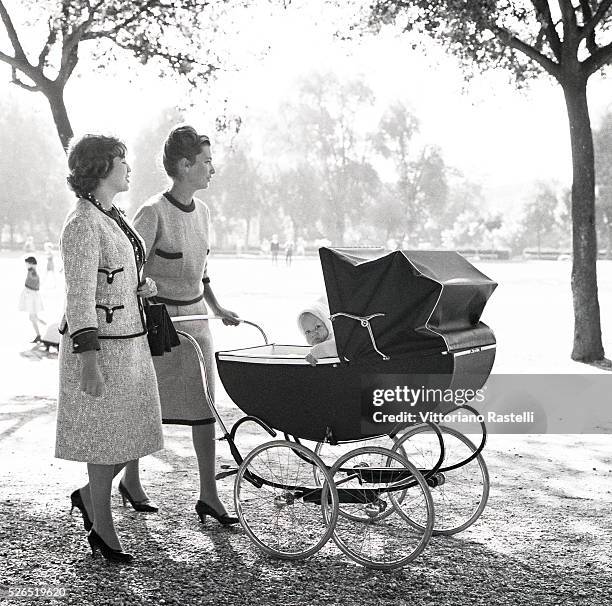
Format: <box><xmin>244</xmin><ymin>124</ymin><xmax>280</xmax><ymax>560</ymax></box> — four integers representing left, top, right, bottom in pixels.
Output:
<box><xmin>0</xmin><ymin>0</ymin><xmax>240</xmax><ymax>148</ymax></box>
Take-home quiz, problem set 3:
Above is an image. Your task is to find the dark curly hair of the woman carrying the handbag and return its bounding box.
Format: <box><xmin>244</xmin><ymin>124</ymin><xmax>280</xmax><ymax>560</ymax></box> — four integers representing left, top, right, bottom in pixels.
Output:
<box><xmin>66</xmin><ymin>135</ymin><xmax>126</xmax><ymax>198</ymax></box>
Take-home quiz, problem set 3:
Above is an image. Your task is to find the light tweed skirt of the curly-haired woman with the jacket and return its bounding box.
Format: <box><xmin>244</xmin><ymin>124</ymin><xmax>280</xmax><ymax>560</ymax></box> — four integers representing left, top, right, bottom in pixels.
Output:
<box><xmin>55</xmin><ymin>336</ymin><xmax>163</xmax><ymax>465</ymax></box>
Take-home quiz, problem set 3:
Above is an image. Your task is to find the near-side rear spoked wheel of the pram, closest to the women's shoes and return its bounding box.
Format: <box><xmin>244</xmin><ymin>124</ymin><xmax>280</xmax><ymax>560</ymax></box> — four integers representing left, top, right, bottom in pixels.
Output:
<box><xmin>234</xmin><ymin>440</ymin><xmax>338</xmax><ymax>560</ymax></box>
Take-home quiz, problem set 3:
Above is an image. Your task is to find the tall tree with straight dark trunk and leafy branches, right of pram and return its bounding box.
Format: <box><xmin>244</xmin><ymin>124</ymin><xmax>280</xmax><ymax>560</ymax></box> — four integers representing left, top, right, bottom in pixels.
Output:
<box><xmin>366</xmin><ymin>0</ymin><xmax>612</xmax><ymax>362</ymax></box>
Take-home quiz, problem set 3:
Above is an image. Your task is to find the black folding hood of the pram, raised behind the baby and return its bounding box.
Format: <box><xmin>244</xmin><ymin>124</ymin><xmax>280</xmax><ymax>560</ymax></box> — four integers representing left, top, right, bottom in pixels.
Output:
<box><xmin>319</xmin><ymin>248</ymin><xmax>497</xmax><ymax>362</ymax></box>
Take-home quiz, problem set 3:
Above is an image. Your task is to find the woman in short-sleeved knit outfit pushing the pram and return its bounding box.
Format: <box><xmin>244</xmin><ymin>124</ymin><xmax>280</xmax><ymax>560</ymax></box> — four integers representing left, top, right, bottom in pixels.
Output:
<box><xmin>120</xmin><ymin>126</ymin><xmax>238</xmax><ymax>526</ymax></box>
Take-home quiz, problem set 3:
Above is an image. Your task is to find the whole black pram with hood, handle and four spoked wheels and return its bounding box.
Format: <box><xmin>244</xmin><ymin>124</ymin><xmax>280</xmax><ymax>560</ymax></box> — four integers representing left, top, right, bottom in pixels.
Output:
<box><xmin>173</xmin><ymin>248</ymin><xmax>497</xmax><ymax>569</ymax></box>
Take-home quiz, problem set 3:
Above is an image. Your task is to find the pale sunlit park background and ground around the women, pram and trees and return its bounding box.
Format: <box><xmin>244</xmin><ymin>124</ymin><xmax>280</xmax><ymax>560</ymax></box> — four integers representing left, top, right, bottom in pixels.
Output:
<box><xmin>0</xmin><ymin>1</ymin><xmax>612</xmax><ymax>605</ymax></box>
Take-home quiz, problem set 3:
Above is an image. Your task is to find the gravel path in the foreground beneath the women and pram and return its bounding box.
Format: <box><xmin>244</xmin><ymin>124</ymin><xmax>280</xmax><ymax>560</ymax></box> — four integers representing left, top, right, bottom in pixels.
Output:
<box><xmin>0</xmin><ymin>398</ymin><xmax>612</xmax><ymax>606</ymax></box>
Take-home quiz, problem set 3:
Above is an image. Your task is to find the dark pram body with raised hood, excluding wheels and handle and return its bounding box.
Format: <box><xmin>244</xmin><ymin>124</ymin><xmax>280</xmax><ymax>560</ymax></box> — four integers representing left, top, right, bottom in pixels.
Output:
<box><xmin>216</xmin><ymin>249</ymin><xmax>496</xmax><ymax>442</ymax></box>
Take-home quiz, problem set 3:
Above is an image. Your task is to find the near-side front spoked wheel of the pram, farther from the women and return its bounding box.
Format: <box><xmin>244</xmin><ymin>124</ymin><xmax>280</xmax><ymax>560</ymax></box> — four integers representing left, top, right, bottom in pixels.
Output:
<box><xmin>322</xmin><ymin>446</ymin><xmax>434</xmax><ymax>570</ymax></box>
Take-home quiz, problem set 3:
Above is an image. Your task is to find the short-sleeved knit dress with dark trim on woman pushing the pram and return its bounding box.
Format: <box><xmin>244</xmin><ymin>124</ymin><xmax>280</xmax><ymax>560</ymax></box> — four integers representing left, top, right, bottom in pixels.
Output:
<box><xmin>134</xmin><ymin>193</ymin><xmax>215</xmax><ymax>425</ymax></box>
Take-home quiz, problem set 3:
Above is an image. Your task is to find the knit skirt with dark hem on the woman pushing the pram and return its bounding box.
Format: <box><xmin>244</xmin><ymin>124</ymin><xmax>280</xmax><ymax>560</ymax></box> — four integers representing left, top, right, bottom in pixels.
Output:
<box><xmin>153</xmin><ymin>301</ymin><xmax>215</xmax><ymax>425</ymax></box>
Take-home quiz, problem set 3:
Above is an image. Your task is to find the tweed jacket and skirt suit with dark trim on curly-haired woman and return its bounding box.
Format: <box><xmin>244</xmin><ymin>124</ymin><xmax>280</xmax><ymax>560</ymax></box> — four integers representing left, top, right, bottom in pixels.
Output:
<box><xmin>55</xmin><ymin>200</ymin><xmax>163</xmax><ymax>465</ymax></box>
